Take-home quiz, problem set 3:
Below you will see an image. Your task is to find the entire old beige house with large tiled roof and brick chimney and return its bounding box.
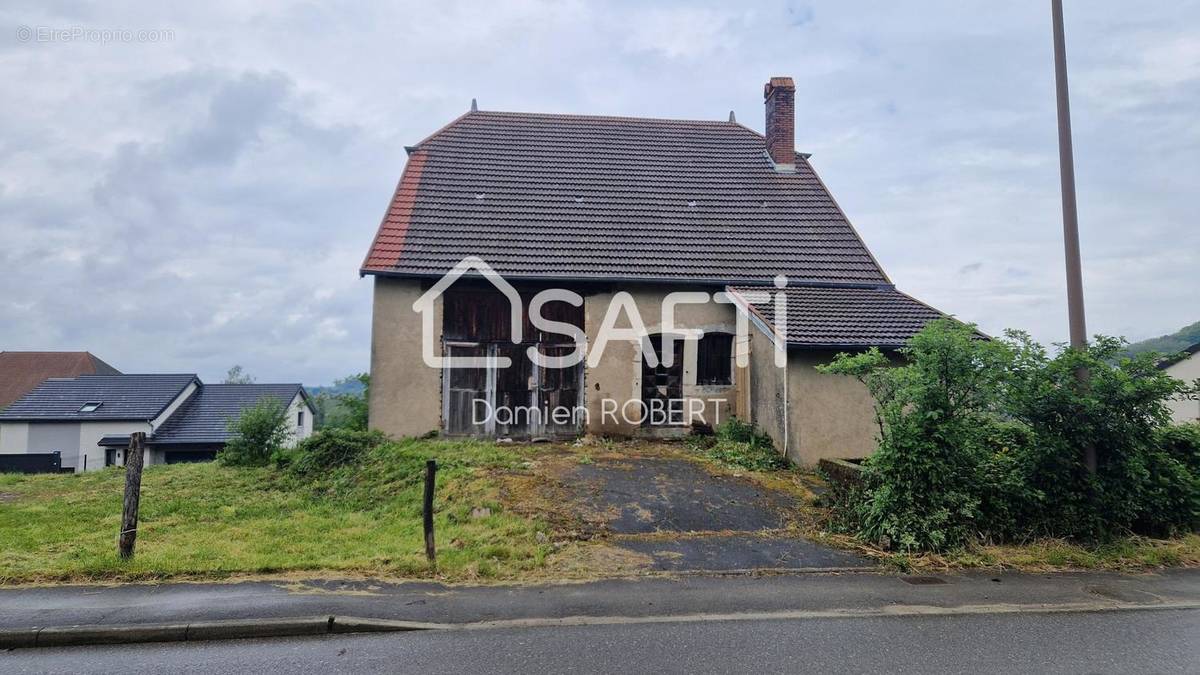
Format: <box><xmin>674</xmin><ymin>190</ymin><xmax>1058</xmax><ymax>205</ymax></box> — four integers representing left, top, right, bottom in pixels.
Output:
<box><xmin>360</xmin><ymin>78</ymin><xmax>960</xmax><ymax>464</ymax></box>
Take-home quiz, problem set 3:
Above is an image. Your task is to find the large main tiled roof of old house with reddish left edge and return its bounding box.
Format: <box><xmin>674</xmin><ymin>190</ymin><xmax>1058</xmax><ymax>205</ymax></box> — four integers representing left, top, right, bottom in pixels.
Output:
<box><xmin>361</xmin><ymin>112</ymin><xmax>889</xmax><ymax>285</ymax></box>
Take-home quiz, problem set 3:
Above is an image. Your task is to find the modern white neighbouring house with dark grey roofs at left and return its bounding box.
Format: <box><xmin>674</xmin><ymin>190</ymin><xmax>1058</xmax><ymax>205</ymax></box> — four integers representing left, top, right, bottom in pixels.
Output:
<box><xmin>0</xmin><ymin>375</ymin><xmax>313</xmax><ymax>472</ymax></box>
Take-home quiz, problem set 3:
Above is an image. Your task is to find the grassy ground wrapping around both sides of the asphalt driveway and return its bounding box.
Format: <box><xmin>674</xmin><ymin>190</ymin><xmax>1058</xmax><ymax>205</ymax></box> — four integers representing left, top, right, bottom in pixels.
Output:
<box><xmin>0</xmin><ymin>432</ymin><xmax>1200</xmax><ymax>584</ymax></box>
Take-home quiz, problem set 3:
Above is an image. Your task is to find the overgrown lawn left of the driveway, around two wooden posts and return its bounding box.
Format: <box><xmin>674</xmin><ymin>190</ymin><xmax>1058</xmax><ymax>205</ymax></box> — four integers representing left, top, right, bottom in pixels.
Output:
<box><xmin>0</xmin><ymin>441</ymin><xmax>548</xmax><ymax>584</ymax></box>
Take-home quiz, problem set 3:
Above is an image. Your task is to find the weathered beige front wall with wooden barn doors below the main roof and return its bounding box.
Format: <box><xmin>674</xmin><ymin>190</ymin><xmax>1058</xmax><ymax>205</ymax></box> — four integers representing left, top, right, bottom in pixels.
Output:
<box><xmin>371</xmin><ymin>277</ymin><xmax>748</xmax><ymax>437</ymax></box>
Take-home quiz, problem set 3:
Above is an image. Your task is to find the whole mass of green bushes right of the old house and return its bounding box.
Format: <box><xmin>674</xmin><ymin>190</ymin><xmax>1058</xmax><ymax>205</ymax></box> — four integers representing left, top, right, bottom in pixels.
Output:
<box><xmin>821</xmin><ymin>319</ymin><xmax>1200</xmax><ymax>550</ymax></box>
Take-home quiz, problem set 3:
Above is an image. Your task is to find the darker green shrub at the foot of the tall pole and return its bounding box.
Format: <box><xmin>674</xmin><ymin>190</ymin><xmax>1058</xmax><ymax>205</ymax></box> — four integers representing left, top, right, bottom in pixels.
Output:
<box><xmin>1002</xmin><ymin>333</ymin><xmax>1190</xmax><ymax>539</ymax></box>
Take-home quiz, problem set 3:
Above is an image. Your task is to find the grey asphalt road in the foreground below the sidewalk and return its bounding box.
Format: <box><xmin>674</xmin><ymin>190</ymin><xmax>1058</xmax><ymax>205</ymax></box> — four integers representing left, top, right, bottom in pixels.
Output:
<box><xmin>0</xmin><ymin>610</ymin><xmax>1200</xmax><ymax>675</ymax></box>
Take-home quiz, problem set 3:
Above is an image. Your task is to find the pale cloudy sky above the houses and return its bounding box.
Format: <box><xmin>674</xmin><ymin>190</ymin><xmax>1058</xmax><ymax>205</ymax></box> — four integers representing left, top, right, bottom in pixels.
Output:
<box><xmin>0</xmin><ymin>0</ymin><xmax>1200</xmax><ymax>384</ymax></box>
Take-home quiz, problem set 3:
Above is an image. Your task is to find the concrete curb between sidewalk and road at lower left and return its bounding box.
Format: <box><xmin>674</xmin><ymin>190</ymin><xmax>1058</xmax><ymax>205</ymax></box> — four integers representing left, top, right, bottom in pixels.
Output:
<box><xmin>0</xmin><ymin>616</ymin><xmax>443</xmax><ymax>650</ymax></box>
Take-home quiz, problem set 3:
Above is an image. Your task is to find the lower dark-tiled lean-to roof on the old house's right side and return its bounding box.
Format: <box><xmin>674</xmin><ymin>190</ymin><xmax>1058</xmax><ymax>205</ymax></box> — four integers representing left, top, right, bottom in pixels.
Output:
<box><xmin>727</xmin><ymin>286</ymin><xmax>946</xmax><ymax>348</ymax></box>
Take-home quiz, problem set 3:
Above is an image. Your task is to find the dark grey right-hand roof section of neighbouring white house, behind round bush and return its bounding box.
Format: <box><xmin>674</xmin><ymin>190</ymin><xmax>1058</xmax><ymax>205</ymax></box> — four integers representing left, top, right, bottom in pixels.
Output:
<box><xmin>149</xmin><ymin>384</ymin><xmax>308</xmax><ymax>446</ymax></box>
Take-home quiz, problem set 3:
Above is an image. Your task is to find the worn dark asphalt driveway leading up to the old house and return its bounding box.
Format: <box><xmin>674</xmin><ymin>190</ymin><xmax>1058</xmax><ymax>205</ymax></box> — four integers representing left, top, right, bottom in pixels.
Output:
<box><xmin>552</xmin><ymin>454</ymin><xmax>871</xmax><ymax>572</ymax></box>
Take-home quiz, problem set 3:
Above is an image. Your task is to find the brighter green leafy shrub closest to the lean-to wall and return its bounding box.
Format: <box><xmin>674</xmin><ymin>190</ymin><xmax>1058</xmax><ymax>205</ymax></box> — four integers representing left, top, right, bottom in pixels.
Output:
<box><xmin>821</xmin><ymin>321</ymin><xmax>1009</xmax><ymax>550</ymax></box>
